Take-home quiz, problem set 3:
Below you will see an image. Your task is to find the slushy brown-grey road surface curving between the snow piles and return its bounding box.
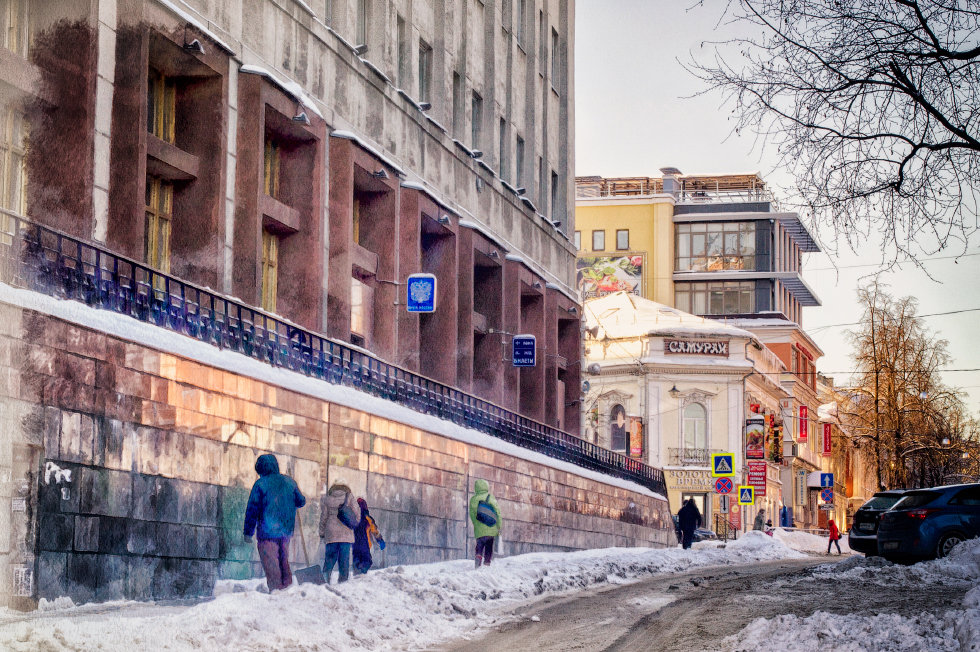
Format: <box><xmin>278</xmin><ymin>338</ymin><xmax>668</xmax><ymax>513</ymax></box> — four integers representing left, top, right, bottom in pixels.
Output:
<box><xmin>440</xmin><ymin>557</ymin><xmax>966</xmax><ymax>652</ymax></box>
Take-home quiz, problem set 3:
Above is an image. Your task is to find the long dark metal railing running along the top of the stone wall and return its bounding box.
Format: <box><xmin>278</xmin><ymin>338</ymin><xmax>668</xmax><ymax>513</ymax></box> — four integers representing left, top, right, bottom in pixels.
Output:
<box><xmin>0</xmin><ymin>213</ymin><xmax>666</xmax><ymax>495</ymax></box>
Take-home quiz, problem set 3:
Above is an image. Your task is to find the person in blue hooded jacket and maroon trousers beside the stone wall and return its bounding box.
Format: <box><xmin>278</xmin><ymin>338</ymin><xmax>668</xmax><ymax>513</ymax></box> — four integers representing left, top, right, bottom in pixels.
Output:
<box><xmin>245</xmin><ymin>454</ymin><xmax>306</xmax><ymax>591</ymax></box>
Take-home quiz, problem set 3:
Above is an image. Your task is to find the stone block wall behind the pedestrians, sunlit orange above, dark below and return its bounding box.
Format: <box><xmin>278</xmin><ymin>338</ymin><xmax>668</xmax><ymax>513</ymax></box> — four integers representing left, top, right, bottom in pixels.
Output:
<box><xmin>0</xmin><ymin>304</ymin><xmax>673</xmax><ymax>606</ymax></box>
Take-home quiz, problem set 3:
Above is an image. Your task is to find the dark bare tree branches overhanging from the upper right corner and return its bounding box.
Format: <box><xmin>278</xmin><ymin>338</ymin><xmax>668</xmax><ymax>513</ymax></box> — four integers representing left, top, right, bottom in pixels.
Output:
<box><xmin>689</xmin><ymin>0</ymin><xmax>980</xmax><ymax>259</ymax></box>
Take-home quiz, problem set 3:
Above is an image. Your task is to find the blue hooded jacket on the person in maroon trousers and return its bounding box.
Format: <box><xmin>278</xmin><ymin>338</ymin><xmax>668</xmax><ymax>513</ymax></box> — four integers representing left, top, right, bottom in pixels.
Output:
<box><xmin>245</xmin><ymin>454</ymin><xmax>306</xmax><ymax>540</ymax></box>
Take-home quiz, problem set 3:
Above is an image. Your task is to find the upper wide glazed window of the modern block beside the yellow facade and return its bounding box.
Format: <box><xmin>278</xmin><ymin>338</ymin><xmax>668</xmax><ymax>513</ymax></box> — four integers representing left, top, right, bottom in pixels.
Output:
<box><xmin>674</xmin><ymin>222</ymin><xmax>756</xmax><ymax>272</ymax></box>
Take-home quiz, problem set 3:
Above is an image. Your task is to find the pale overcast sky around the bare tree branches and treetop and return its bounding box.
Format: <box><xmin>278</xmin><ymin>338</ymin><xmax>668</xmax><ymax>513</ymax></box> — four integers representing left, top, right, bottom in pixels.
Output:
<box><xmin>575</xmin><ymin>0</ymin><xmax>980</xmax><ymax>416</ymax></box>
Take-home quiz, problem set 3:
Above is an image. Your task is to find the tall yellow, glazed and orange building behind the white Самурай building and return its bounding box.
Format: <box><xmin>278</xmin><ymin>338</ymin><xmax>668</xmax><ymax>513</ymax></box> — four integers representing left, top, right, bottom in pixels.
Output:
<box><xmin>573</xmin><ymin>173</ymin><xmax>843</xmax><ymax>526</ymax></box>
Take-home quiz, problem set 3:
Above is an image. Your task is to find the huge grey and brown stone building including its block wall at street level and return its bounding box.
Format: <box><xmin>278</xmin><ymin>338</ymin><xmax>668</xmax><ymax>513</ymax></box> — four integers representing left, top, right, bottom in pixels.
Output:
<box><xmin>0</xmin><ymin>0</ymin><xmax>669</xmax><ymax>606</ymax></box>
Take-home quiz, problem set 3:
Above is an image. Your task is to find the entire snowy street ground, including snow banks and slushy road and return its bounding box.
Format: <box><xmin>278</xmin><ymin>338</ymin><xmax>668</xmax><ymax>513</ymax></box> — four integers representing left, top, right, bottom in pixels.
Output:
<box><xmin>0</xmin><ymin>532</ymin><xmax>980</xmax><ymax>652</ymax></box>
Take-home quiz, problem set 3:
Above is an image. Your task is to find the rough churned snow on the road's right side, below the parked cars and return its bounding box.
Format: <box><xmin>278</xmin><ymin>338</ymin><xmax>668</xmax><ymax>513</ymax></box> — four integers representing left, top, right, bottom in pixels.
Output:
<box><xmin>723</xmin><ymin>539</ymin><xmax>980</xmax><ymax>652</ymax></box>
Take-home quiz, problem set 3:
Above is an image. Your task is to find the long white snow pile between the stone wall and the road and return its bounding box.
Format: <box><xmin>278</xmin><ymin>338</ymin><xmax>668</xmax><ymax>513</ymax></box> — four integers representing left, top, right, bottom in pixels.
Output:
<box><xmin>0</xmin><ymin>533</ymin><xmax>805</xmax><ymax>652</ymax></box>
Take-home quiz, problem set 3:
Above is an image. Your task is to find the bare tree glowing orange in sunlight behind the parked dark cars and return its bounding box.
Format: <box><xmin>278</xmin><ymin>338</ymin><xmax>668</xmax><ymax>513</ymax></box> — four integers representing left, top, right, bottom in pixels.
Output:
<box><xmin>838</xmin><ymin>283</ymin><xmax>977</xmax><ymax>488</ymax></box>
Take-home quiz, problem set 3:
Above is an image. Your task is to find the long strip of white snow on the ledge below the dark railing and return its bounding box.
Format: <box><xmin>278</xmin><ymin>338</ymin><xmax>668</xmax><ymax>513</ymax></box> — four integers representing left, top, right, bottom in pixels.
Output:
<box><xmin>0</xmin><ymin>283</ymin><xmax>667</xmax><ymax>502</ymax></box>
